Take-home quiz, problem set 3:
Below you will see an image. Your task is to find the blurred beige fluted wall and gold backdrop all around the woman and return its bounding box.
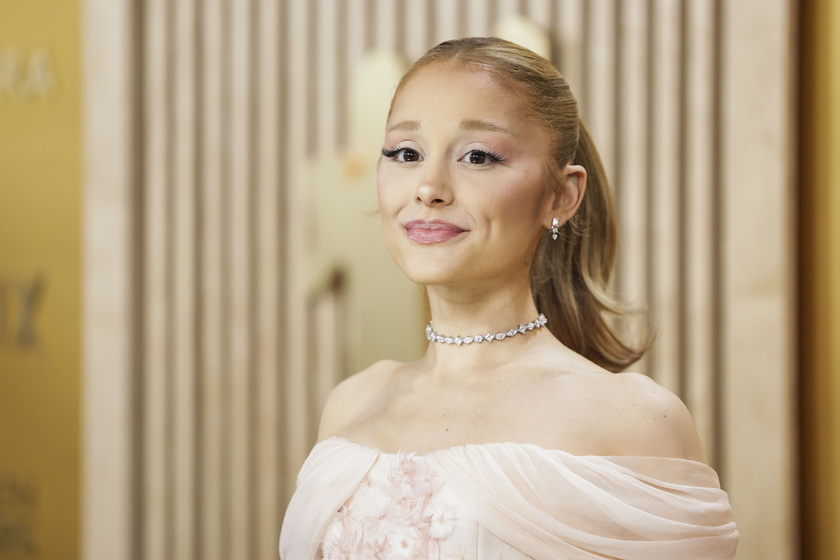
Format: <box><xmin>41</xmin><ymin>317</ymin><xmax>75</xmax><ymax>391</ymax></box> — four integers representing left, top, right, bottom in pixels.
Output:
<box><xmin>0</xmin><ymin>0</ymin><xmax>840</xmax><ymax>560</ymax></box>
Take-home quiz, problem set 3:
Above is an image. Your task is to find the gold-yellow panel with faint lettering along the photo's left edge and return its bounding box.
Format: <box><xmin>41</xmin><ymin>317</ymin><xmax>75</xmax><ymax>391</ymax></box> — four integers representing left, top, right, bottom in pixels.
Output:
<box><xmin>0</xmin><ymin>0</ymin><xmax>81</xmax><ymax>560</ymax></box>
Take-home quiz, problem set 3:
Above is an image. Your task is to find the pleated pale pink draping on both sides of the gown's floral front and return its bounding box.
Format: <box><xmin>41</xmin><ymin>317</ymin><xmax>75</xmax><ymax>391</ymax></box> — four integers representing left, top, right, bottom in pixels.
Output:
<box><xmin>280</xmin><ymin>438</ymin><xmax>738</xmax><ymax>560</ymax></box>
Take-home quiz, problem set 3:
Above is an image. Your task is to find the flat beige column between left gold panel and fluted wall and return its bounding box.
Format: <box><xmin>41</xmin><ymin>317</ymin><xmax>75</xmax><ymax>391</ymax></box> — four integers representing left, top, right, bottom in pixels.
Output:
<box><xmin>81</xmin><ymin>0</ymin><xmax>136</xmax><ymax>560</ymax></box>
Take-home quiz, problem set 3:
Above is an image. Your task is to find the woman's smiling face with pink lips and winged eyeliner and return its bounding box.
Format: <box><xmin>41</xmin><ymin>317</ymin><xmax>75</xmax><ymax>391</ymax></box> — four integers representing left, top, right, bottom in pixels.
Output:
<box><xmin>376</xmin><ymin>62</ymin><xmax>556</xmax><ymax>285</ymax></box>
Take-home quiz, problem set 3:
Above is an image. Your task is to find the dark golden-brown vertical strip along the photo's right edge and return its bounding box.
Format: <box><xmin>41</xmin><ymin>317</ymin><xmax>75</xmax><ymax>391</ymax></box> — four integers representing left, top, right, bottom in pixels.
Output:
<box><xmin>797</xmin><ymin>0</ymin><xmax>840</xmax><ymax>558</ymax></box>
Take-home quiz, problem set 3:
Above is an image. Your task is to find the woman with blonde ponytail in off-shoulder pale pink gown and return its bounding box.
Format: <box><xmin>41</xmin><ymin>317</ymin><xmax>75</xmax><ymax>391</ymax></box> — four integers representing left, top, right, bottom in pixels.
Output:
<box><xmin>280</xmin><ymin>38</ymin><xmax>738</xmax><ymax>560</ymax></box>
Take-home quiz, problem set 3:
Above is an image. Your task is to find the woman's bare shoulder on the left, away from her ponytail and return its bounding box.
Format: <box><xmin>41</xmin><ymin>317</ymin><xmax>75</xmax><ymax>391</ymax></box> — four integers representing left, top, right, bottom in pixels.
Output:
<box><xmin>318</xmin><ymin>360</ymin><xmax>401</xmax><ymax>440</ymax></box>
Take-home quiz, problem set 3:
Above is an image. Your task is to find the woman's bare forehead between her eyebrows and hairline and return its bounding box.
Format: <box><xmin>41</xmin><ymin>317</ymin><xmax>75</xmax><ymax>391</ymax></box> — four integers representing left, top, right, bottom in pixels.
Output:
<box><xmin>390</xmin><ymin>62</ymin><xmax>525</xmax><ymax>121</ymax></box>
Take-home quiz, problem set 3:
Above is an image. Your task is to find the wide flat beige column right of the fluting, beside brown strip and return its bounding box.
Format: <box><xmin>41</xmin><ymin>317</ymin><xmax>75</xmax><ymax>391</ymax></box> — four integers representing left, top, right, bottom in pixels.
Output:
<box><xmin>716</xmin><ymin>0</ymin><xmax>795</xmax><ymax>560</ymax></box>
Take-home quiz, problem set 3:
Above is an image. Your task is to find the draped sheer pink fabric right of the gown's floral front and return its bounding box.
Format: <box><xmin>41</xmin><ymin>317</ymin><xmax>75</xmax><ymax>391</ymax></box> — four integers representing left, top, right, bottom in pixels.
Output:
<box><xmin>429</xmin><ymin>444</ymin><xmax>738</xmax><ymax>560</ymax></box>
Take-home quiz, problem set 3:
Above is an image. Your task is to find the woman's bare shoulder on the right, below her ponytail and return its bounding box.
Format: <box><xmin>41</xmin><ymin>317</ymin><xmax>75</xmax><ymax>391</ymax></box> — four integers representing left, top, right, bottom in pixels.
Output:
<box><xmin>584</xmin><ymin>373</ymin><xmax>706</xmax><ymax>463</ymax></box>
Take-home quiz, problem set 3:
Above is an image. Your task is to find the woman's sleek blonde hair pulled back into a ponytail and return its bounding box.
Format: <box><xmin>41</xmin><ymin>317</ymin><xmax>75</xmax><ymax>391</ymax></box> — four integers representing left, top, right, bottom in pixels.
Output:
<box><xmin>394</xmin><ymin>37</ymin><xmax>650</xmax><ymax>371</ymax></box>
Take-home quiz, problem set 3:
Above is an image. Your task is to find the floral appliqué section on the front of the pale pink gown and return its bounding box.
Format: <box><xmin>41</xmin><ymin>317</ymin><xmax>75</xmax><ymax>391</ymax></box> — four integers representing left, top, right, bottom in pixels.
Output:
<box><xmin>321</xmin><ymin>452</ymin><xmax>466</xmax><ymax>560</ymax></box>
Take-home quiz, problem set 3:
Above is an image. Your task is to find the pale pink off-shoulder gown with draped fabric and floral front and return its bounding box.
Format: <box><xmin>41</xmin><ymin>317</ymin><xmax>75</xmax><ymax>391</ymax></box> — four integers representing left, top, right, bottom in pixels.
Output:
<box><xmin>280</xmin><ymin>437</ymin><xmax>738</xmax><ymax>560</ymax></box>
